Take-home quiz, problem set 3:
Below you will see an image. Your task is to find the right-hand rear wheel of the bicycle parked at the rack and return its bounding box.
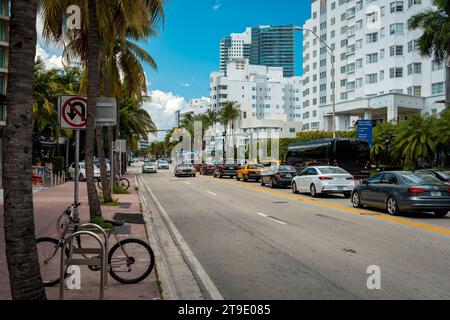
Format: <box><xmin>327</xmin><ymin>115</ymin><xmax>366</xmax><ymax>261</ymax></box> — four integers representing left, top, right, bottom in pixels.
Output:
<box><xmin>108</xmin><ymin>239</ymin><xmax>155</xmax><ymax>284</ymax></box>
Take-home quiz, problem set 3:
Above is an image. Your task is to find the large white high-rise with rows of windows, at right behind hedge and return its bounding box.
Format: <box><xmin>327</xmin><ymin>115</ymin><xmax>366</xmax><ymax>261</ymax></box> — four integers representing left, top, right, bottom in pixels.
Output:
<box><xmin>301</xmin><ymin>0</ymin><xmax>445</xmax><ymax>130</ymax></box>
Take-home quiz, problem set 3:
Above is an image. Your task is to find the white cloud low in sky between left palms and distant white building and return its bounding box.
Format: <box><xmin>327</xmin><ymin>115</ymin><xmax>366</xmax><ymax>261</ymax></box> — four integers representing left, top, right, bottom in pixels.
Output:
<box><xmin>144</xmin><ymin>90</ymin><xmax>186</xmax><ymax>137</ymax></box>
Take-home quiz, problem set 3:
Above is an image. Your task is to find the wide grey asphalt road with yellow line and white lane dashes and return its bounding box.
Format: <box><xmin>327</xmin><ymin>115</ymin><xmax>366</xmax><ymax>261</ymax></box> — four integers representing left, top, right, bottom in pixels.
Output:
<box><xmin>144</xmin><ymin>170</ymin><xmax>450</xmax><ymax>300</ymax></box>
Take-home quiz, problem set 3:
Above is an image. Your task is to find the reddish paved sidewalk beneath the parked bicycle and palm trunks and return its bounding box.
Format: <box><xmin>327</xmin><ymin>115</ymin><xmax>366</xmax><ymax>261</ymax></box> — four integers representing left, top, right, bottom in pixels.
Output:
<box><xmin>0</xmin><ymin>176</ymin><xmax>160</xmax><ymax>300</ymax></box>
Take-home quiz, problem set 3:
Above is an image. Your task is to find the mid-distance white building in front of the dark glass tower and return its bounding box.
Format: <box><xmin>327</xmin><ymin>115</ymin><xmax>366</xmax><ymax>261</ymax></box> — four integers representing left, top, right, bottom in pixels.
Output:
<box><xmin>210</xmin><ymin>59</ymin><xmax>302</xmax><ymax>137</ymax></box>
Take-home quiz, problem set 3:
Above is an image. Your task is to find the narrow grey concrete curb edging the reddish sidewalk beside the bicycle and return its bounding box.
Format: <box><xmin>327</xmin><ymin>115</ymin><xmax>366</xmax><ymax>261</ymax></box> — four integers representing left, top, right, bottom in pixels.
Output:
<box><xmin>135</xmin><ymin>175</ymin><xmax>178</xmax><ymax>300</ymax></box>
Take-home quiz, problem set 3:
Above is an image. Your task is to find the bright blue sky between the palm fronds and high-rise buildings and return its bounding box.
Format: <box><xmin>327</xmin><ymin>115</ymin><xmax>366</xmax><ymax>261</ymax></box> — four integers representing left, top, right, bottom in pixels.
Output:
<box><xmin>142</xmin><ymin>0</ymin><xmax>310</xmax><ymax>100</ymax></box>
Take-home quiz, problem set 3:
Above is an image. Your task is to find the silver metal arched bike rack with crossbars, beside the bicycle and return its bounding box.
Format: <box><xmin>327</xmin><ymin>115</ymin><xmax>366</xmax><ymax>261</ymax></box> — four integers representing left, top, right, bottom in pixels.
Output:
<box><xmin>59</xmin><ymin>230</ymin><xmax>107</xmax><ymax>300</ymax></box>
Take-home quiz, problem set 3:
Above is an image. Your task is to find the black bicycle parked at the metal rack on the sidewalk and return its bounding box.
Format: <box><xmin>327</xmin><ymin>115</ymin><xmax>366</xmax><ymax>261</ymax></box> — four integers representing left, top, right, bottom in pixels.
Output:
<box><xmin>36</xmin><ymin>203</ymin><xmax>155</xmax><ymax>287</ymax></box>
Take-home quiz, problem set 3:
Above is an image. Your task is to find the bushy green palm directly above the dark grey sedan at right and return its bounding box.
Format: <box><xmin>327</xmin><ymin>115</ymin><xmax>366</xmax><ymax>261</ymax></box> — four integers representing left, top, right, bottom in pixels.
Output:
<box><xmin>393</xmin><ymin>113</ymin><xmax>437</xmax><ymax>169</ymax></box>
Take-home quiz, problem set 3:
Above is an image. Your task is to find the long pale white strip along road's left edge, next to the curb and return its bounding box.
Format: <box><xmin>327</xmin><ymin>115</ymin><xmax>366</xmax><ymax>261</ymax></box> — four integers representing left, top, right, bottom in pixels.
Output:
<box><xmin>136</xmin><ymin>175</ymin><xmax>224</xmax><ymax>300</ymax></box>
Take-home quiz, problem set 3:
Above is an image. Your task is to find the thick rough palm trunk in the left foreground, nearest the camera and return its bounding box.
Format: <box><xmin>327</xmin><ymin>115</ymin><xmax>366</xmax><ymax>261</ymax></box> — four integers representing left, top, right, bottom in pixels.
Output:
<box><xmin>3</xmin><ymin>0</ymin><xmax>46</xmax><ymax>300</ymax></box>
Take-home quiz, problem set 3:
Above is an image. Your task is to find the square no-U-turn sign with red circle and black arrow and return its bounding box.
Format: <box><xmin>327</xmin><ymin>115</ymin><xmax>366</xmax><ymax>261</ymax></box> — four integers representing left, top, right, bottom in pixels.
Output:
<box><xmin>58</xmin><ymin>96</ymin><xmax>87</xmax><ymax>130</ymax></box>
